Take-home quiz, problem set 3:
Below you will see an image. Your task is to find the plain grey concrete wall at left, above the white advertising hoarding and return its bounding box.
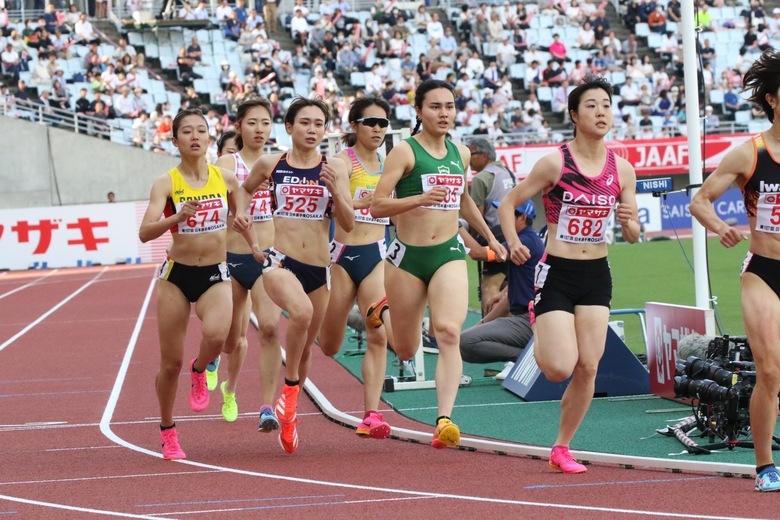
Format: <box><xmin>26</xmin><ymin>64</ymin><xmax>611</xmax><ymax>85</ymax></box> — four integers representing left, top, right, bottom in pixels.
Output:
<box><xmin>0</xmin><ymin>117</ymin><xmax>179</xmax><ymax>208</ymax></box>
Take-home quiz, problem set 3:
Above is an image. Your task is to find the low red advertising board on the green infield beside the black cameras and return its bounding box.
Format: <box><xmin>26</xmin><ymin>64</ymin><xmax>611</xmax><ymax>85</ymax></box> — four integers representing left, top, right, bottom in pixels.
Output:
<box><xmin>645</xmin><ymin>303</ymin><xmax>715</xmax><ymax>399</ymax></box>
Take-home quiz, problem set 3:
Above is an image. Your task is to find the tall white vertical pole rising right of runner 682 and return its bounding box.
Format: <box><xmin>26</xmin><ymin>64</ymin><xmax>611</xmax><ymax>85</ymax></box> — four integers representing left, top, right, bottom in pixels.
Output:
<box><xmin>680</xmin><ymin>1</ymin><xmax>710</xmax><ymax>309</ymax></box>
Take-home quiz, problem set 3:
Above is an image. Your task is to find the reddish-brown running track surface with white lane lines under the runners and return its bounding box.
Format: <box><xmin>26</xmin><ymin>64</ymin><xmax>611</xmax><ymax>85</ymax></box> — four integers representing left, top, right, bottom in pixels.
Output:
<box><xmin>0</xmin><ymin>266</ymin><xmax>778</xmax><ymax>519</ymax></box>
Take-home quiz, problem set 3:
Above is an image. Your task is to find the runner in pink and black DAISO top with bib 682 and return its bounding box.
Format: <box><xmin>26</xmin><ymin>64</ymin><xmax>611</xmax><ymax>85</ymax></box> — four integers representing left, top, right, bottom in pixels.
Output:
<box><xmin>499</xmin><ymin>77</ymin><xmax>640</xmax><ymax>473</ymax></box>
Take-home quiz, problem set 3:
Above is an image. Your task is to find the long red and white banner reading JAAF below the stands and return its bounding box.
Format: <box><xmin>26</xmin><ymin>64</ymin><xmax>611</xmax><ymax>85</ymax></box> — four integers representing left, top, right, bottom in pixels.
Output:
<box><xmin>496</xmin><ymin>134</ymin><xmax>750</xmax><ymax>178</ymax></box>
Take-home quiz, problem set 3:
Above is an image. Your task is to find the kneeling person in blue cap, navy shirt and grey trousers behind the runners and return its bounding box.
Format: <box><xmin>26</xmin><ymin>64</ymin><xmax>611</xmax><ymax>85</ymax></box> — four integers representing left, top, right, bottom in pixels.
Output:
<box><xmin>460</xmin><ymin>200</ymin><xmax>544</xmax><ymax>379</ymax></box>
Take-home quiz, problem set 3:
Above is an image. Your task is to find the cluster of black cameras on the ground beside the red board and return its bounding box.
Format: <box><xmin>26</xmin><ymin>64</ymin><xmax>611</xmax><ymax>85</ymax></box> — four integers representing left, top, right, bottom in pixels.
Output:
<box><xmin>658</xmin><ymin>336</ymin><xmax>780</xmax><ymax>454</ymax></box>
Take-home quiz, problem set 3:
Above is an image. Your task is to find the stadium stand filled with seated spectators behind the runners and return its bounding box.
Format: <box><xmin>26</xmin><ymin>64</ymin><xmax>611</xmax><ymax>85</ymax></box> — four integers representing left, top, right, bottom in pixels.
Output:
<box><xmin>0</xmin><ymin>0</ymin><xmax>780</xmax><ymax>153</ymax></box>
